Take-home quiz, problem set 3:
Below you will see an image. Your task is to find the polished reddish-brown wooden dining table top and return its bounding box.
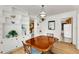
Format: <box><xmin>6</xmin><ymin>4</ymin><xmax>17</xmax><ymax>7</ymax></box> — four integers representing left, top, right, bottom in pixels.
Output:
<box><xmin>25</xmin><ymin>35</ymin><xmax>56</xmax><ymax>53</ymax></box>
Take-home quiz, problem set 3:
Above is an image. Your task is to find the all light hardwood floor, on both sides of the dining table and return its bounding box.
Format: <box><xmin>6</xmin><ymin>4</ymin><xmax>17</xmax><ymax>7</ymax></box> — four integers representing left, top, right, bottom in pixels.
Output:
<box><xmin>7</xmin><ymin>42</ymin><xmax>79</xmax><ymax>54</ymax></box>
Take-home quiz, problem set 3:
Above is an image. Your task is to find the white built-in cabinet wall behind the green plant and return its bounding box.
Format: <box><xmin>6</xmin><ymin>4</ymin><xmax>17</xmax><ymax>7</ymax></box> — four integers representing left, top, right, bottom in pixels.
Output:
<box><xmin>0</xmin><ymin>8</ymin><xmax>30</xmax><ymax>53</ymax></box>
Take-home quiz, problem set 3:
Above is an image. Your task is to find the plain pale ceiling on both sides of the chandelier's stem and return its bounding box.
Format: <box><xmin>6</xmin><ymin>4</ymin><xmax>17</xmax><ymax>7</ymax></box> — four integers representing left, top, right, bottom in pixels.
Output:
<box><xmin>0</xmin><ymin>5</ymin><xmax>79</xmax><ymax>15</ymax></box>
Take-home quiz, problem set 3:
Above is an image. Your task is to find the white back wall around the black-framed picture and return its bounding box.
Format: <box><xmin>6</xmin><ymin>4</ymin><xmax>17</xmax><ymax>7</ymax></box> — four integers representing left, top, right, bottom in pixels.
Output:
<box><xmin>34</xmin><ymin>16</ymin><xmax>61</xmax><ymax>39</ymax></box>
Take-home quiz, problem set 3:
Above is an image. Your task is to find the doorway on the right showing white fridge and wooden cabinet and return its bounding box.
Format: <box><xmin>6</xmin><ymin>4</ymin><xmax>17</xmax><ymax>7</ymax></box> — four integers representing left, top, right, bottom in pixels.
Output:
<box><xmin>61</xmin><ymin>17</ymin><xmax>73</xmax><ymax>43</ymax></box>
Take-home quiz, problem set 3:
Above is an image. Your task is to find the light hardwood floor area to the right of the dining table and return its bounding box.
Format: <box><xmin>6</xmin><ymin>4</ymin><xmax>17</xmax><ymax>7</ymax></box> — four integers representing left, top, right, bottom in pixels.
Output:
<box><xmin>51</xmin><ymin>42</ymin><xmax>79</xmax><ymax>54</ymax></box>
